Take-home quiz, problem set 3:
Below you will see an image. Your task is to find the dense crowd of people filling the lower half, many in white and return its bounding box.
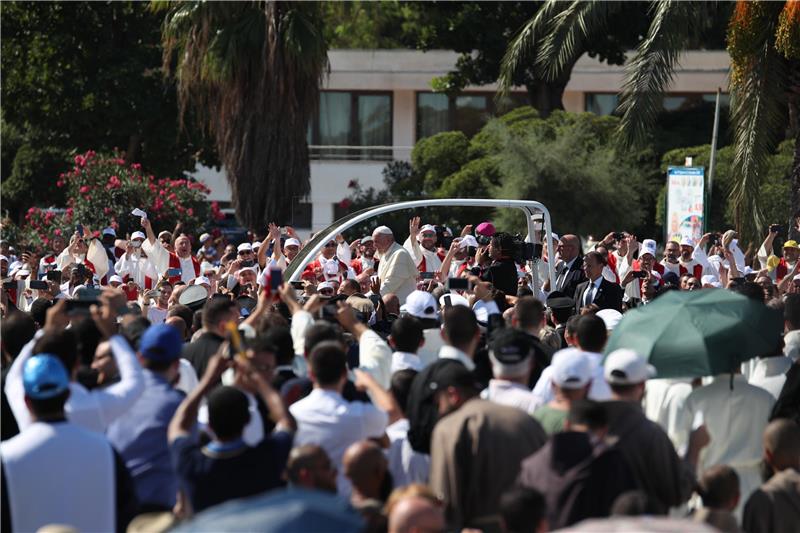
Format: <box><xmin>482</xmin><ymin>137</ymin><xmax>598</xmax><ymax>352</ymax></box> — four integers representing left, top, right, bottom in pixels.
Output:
<box><xmin>0</xmin><ymin>215</ymin><xmax>800</xmax><ymax>533</ymax></box>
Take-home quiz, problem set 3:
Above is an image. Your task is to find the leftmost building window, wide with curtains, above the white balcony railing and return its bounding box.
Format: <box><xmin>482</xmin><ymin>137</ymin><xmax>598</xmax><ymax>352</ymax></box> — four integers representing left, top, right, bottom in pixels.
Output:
<box><xmin>308</xmin><ymin>91</ymin><xmax>392</xmax><ymax>161</ymax></box>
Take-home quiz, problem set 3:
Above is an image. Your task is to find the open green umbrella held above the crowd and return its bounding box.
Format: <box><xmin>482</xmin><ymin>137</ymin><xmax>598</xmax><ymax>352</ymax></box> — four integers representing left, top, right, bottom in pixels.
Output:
<box><xmin>605</xmin><ymin>289</ymin><xmax>783</xmax><ymax>378</ymax></box>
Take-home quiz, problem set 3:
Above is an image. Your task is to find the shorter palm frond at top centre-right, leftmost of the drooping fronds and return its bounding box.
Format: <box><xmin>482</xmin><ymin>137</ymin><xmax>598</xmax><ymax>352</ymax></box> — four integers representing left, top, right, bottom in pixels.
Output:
<box><xmin>536</xmin><ymin>0</ymin><xmax>619</xmax><ymax>81</ymax></box>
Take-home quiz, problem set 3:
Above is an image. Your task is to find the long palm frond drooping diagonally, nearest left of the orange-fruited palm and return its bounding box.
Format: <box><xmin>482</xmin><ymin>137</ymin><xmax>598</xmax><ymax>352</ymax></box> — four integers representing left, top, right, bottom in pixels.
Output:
<box><xmin>619</xmin><ymin>0</ymin><xmax>697</xmax><ymax>147</ymax></box>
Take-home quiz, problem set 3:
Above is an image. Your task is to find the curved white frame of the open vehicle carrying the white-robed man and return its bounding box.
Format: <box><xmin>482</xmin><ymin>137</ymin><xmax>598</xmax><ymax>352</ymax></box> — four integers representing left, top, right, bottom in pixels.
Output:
<box><xmin>284</xmin><ymin>198</ymin><xmax>556</xmax><ymax>293</ymax></box>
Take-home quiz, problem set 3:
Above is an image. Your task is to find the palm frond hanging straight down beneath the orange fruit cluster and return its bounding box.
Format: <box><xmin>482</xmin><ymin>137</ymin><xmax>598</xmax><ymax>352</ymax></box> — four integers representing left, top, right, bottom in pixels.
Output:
<box><xmin>730</xmin><ymin>42</ymin><xmax>789</xmax><ymax>237</ymax></box>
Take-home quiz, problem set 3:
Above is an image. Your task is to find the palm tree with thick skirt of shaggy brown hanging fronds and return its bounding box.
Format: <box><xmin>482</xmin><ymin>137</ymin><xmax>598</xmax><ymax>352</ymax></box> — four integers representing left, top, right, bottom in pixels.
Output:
<box><xmin>153</xmin><ymin>0</ymin><xmax>328</xmax><ymax>229</ymax></box>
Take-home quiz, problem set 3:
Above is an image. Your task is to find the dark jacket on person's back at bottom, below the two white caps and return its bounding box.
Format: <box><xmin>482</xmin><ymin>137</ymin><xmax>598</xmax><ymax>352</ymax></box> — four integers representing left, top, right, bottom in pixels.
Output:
<box><xmin>517</xmin><ymin>431</ymin><xmax>638</xmax><ymax>529</ymax></box>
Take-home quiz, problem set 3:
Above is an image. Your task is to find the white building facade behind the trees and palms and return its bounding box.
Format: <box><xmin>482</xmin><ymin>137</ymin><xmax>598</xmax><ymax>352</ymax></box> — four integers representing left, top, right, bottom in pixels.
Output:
<box><xmin>195</xmin><ymin>50</ymin><xmax>730</xmax><ymax>234</ymax></box>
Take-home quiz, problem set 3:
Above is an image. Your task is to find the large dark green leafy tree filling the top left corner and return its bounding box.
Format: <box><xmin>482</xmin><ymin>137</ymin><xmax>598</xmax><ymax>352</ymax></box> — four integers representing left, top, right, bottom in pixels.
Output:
<box><xmin>0</xmin><ymin>1</ymin><xmax>214</xmax><ymax>218</ymax></box>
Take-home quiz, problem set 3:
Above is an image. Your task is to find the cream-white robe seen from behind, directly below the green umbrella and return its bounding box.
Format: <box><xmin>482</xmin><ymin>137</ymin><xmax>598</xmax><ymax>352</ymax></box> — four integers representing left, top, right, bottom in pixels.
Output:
<box><xmin>682</xmin><ymin>374</ymin><xmax>775</xmax><ymax>508</ymax></box>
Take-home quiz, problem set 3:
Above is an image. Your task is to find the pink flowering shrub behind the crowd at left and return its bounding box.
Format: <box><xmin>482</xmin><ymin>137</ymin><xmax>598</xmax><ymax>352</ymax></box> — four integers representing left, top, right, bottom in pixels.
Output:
<box><xmin>14</xmin><ymin>150</ymin><xmax>225</xmax><ymax>249</ymax></box>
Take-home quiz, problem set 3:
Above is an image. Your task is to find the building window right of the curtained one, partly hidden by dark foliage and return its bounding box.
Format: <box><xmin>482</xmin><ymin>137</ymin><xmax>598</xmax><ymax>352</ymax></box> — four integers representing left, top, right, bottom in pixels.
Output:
<box><xmin>417</xmin><ymin>92</ymin><xmax>528</xmax><ymax>139</ymax></box>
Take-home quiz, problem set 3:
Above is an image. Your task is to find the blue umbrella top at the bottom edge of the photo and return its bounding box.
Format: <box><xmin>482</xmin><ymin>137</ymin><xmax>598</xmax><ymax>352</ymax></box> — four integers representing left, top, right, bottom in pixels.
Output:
<box><xmin>172</xmin><ymin>489</ymin><xmax>364</xmax><ymax>533</ymax></box>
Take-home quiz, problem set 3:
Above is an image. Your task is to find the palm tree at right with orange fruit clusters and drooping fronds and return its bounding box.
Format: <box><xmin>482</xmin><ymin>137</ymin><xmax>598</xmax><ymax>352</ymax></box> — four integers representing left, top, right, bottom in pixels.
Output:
<box><xmin>500</xmin><ymin>0</ymin><xmax>800</xmax><ymax>241</ymax></box>
